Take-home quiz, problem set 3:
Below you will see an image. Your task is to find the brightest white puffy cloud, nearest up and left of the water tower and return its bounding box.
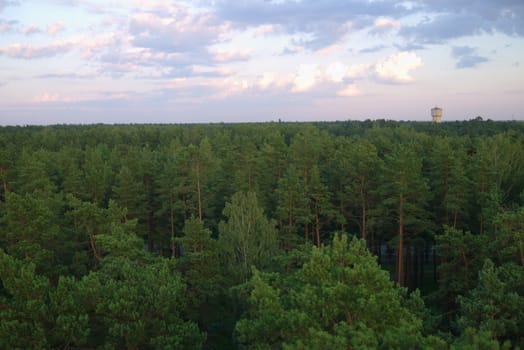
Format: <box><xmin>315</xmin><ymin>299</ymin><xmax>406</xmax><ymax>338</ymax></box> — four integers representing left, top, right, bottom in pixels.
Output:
<box><xmin>375</xmin><ymin>51</ymin><xmax>423</xmax><ymax>83</ymax></box>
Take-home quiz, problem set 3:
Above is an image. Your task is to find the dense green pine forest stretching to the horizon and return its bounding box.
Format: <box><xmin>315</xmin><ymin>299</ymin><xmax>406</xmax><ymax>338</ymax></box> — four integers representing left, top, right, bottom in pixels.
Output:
<box><xmin>0</xmin><ymin>117</ymin><xmax>524</xmax><ymax>349</ymax></box>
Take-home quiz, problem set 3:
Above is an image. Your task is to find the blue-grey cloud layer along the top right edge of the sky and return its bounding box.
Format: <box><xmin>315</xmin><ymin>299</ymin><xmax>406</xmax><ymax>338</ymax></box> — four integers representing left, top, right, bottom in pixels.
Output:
<box><xmin>213</xmin><ymin>0</ymin><xmax>524</xmax><ymax>49</ymax></box>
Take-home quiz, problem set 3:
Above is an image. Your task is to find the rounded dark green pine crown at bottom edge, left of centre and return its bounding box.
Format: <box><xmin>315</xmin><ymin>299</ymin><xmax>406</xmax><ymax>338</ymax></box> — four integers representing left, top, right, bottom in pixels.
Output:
<box><xmin>80</xmin><ymin>258</ymin><xmax>205</xmax><ymax>349</ymax></box>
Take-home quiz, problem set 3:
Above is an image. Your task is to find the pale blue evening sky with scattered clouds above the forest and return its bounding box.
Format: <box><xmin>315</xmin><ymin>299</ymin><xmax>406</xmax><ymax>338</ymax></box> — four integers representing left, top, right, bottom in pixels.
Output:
<box><xmin>0</xmin><ymin>0</ymin><xmax>524</xmax><ymax>125</ymax></box>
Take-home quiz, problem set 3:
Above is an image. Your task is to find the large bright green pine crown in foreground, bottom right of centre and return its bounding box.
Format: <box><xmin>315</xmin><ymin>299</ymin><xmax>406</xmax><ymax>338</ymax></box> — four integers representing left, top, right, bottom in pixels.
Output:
<box><xmin>236</xmin><ymin>235</ymin><xmax>438</xmax><ymax>349</ymax></box>
